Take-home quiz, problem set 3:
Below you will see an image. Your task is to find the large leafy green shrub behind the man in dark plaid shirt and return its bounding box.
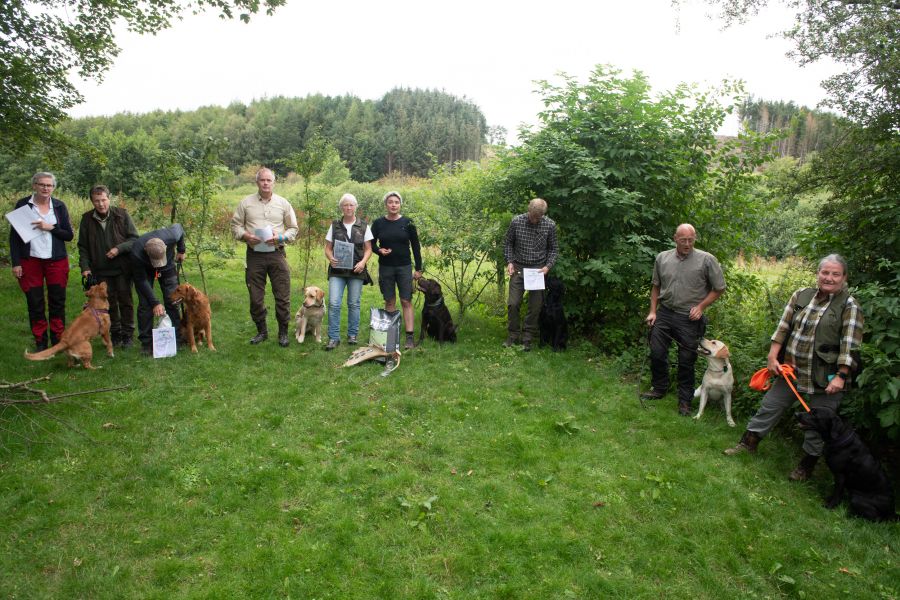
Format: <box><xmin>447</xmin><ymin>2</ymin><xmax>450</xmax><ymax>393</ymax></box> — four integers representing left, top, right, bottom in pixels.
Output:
<box><xmin>506</xmin><ymin>67</ymin><xmax>767</xmax><ymax>351</ymax></box>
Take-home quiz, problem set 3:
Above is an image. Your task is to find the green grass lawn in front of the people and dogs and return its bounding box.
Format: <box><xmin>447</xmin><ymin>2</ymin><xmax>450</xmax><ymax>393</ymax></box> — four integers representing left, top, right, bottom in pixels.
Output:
<box><xmin>0</xmin><ymin>264</ymin><xmax>900</xmax><ymax>599</ymax></box>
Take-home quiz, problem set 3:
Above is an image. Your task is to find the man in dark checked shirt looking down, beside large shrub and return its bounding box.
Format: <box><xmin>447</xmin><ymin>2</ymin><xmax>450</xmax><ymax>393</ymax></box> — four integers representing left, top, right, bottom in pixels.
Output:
<box><xmin>503</xmin><ymin>198</ymin><xmax>559</xmax><ymax>352</ymax></box>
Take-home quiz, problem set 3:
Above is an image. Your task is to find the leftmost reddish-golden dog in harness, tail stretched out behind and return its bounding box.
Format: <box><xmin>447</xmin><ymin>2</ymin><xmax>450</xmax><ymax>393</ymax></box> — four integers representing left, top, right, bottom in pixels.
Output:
<box><xmin>25</xmin><ymin>281</ymin><xmax>115</xmax><ymax>369</ymax></box>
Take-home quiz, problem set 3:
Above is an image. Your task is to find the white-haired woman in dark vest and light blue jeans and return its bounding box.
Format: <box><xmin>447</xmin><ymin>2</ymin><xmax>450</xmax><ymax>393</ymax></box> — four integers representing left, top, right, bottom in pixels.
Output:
<box><xmin>325</xmin><ymin>194</ymin><xmax>372</xmax><ymax>350</ymax></box>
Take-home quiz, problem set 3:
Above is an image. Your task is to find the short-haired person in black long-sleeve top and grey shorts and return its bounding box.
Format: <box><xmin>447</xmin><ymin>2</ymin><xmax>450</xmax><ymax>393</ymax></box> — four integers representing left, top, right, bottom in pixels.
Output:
<box><xmin>372</xmin><ymin>192</ymin><xmax>422</xmax><ymax>349</ymax></box>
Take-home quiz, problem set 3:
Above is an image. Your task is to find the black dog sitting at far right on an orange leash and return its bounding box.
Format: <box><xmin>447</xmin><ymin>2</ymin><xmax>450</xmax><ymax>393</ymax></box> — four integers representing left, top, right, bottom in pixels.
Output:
<box><xmin>797</xmin><ymin>406</ymin><xmax>898</xmax><ymax>521</ymax></box>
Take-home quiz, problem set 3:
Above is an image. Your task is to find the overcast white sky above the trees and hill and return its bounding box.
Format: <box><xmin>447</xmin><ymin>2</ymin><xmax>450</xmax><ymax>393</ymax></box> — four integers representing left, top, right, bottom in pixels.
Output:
<box><xmin>72</xmin><ymin>0</ymin><xmax>833</xmax><ymax>142</ymax></box>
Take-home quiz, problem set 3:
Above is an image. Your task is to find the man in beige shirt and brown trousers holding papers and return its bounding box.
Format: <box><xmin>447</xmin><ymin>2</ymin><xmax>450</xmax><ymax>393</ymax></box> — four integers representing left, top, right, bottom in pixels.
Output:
<box><xmin>231</xmin><ymin>168</ymin><xmax>297</xmax><ymax>347</ymax></box>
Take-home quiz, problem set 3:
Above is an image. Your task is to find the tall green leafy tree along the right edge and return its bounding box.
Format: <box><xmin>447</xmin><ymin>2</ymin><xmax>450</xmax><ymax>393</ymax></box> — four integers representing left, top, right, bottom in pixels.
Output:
<box><xmin>707</xmin><ymin>0</ymin><xmax>900</xmax><ymax>439</ymax></box>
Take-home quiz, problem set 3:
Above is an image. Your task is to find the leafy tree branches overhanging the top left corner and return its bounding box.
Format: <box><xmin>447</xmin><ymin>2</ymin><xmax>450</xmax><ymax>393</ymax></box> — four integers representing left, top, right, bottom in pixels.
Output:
<box><xmin>0</xmin><ymin>0</ymin><xmax>285</xmax><ymax>149</ymax></box>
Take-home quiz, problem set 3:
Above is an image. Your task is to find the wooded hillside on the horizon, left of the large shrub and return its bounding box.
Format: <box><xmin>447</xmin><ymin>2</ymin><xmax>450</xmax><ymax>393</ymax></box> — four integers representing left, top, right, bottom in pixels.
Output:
<box><xmin>0</xmin><ymin>88</ymin><xmax>488</xmax><ymax>186</ymax></box>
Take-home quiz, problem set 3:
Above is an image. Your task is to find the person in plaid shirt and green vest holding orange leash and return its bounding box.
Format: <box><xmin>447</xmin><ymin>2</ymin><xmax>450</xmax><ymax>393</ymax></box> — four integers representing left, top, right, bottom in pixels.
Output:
<box><xmin>725</xmin><ymin>254</ymin><xmax>863</xmax><ymax>481</ymax></box>
